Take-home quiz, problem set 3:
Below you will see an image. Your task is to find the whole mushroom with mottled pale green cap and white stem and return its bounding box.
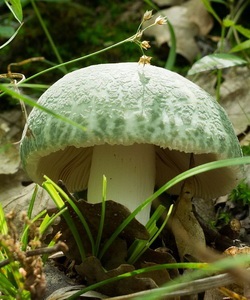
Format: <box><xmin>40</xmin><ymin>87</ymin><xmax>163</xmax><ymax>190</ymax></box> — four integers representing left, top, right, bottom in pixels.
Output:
<box><xmin>20</xmin><ymin>63</ymin><xmax>242</xmax><ymax>224</ymax></box>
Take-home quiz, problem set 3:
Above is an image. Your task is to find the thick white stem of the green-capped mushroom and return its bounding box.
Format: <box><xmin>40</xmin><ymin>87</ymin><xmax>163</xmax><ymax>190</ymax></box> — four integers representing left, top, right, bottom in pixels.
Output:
<box><xmin>87</xmin><ymin>144</ymin><xmax>155</xmax><ymax>225</ymax></box>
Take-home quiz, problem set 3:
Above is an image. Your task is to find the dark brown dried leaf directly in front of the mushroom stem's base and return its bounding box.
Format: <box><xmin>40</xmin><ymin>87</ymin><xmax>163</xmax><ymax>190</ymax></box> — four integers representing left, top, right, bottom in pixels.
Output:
<box><xmin>46</xmin><ymin>200</ymin><xmax>149</xmax><ymax>262</ymax></box>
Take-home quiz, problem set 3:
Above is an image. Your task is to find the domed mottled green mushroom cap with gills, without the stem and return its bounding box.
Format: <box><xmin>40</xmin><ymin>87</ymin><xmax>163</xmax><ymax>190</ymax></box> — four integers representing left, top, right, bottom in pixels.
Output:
<box><xmin>20</xmin><ymin>63</ymin><xmax>241</xmax><ymax>197</ymax></box>
